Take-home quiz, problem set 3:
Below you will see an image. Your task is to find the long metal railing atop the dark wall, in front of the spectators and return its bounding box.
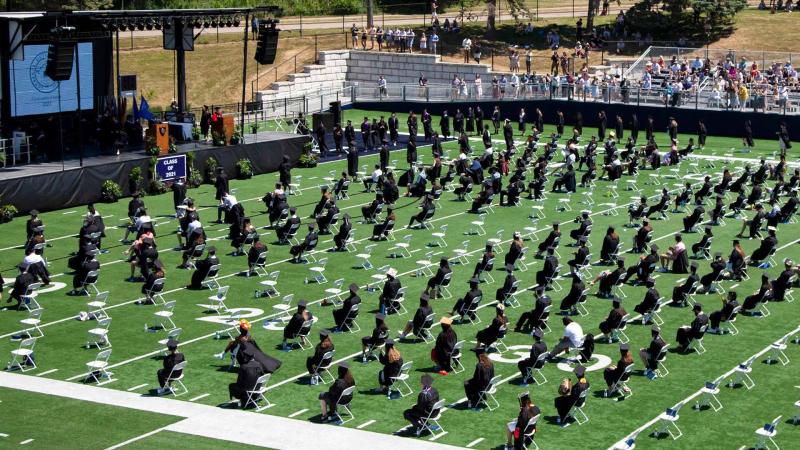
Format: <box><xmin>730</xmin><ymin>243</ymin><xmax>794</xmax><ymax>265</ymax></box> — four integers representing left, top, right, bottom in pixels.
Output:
<box><xmin>353</xmin><ymin>79</ymin><xmax>800</xmax><ymax>115</ymax></box>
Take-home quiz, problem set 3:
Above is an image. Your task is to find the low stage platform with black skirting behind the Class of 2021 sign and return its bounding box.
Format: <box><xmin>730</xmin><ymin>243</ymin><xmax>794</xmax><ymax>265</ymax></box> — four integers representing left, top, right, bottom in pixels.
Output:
<box><xmin>0</xmin><ymin>132</ymin><xmax>309</xmax><ymax>212</ymax></box>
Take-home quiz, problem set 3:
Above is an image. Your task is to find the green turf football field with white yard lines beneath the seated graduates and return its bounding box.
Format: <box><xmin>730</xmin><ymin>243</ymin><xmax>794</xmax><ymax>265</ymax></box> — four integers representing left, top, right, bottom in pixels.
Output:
<box><xmin>0</xmin><ymin>110</ymin><xmax>800</xmax><ymax>449</ymax></box>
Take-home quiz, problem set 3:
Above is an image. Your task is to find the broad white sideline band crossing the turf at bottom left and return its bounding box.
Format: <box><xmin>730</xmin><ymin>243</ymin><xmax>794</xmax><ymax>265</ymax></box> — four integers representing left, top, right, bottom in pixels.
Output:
<box><xmin>0</xmin><ymin>372</ymin><xmax>458</xmax><ymax>450</ymax></box>
